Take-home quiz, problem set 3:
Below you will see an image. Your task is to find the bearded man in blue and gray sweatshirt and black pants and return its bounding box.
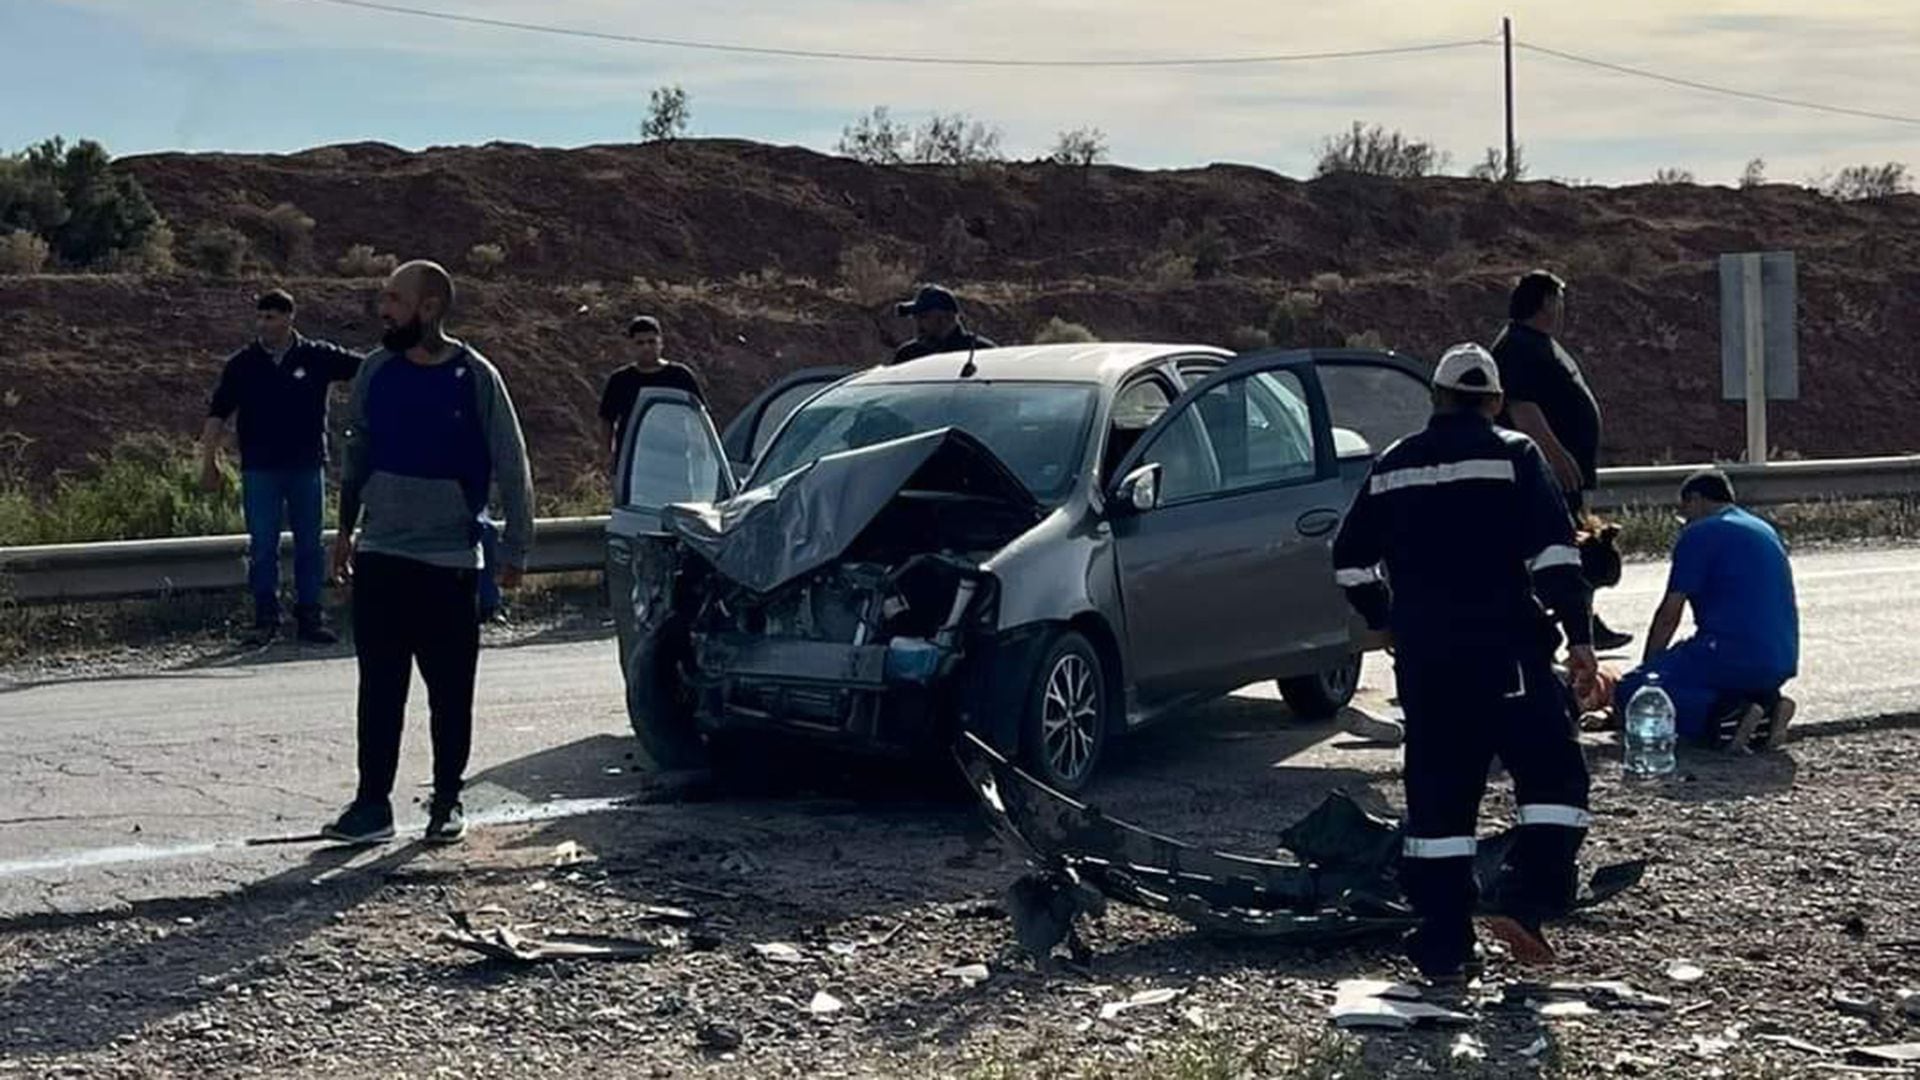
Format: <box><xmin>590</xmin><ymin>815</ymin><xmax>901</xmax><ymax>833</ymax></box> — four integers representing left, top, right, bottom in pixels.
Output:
<box><xmin>323</xmin><ymin>261</ymin><xmax>534</xmax><ymax>844</ymax></box>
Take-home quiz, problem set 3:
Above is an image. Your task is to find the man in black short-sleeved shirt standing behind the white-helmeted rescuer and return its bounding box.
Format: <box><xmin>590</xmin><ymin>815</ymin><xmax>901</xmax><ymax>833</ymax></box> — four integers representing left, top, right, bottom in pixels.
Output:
<box><xmin>1492</xmin><ymin>269</ymin><xmax>1634</xmax><ymax>650</ymax></box>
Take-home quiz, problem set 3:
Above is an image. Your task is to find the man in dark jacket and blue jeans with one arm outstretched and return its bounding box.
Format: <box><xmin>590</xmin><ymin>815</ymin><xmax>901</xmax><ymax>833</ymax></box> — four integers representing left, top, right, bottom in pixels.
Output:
<box><xmin>200</xmin><ymin>288</ymin><xmax>361</xmax><ymax>644</ymax></box>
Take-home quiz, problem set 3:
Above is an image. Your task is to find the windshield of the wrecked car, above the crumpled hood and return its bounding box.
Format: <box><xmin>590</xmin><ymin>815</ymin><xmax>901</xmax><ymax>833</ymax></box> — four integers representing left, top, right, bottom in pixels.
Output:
<box><xmin>753</xmin><ymin>380</ymin><xmax>1094</xmax><ymax>503</ymax></box>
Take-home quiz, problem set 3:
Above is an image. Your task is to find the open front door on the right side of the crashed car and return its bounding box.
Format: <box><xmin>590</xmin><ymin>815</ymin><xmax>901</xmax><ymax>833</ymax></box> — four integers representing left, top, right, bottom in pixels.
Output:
<box><xmin>1106</xmin><ymin>350</ymin><xmax>1352</xmax><ymax>700</ymax></box>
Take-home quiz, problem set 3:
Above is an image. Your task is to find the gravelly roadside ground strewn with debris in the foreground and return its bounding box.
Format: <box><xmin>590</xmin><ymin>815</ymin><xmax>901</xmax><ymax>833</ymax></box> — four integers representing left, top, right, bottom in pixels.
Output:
<box><xmin>0</xmin><ymin>705</ymin><xmax>1920</xmax><ymax>1078</ymax></box>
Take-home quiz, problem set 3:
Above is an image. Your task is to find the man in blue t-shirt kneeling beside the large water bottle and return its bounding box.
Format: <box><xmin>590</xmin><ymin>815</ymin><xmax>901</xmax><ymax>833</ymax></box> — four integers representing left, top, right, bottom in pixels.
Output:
<box><xmin>1617</xmin><ymin>469</ymin><xmax>1799</xmax><ymax>749</ymax></box>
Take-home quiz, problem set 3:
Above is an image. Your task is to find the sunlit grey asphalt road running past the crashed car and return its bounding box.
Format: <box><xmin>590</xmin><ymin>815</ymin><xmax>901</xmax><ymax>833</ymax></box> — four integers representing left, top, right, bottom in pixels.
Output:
<box><xmin>0</xmin><ymin>550</ymin><xmax>1920</xmax><ymax>917</ymax></box>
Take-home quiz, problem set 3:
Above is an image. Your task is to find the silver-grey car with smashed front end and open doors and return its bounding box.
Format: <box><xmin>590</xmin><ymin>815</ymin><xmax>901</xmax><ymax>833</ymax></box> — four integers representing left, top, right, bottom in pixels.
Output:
<box><xmin>607</xmin><ymin>344</ymin><xmax>1428</xmax><ymax>792</ymax></box>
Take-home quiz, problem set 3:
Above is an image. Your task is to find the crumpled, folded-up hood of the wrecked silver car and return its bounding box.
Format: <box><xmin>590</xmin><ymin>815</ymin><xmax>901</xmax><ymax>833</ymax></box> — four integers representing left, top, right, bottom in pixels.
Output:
<box><xmin>662</xmin><ymin>429</ymin><xmax>1041</xmax><ymax>592</ymax></box>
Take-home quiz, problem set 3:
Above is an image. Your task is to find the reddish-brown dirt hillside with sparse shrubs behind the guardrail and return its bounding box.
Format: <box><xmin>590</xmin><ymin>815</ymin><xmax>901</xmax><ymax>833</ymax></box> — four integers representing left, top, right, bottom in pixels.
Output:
<box><xmin>0</xmin><ymin>142</ymin><xmax>1920</xmax><ymax>482</ymax></box>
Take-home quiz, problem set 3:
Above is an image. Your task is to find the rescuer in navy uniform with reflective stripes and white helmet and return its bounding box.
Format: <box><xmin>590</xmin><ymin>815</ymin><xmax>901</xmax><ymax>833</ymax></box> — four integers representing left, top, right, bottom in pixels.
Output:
<box><xmin>1332</xmin><ymin>344</ymin><xmax>1596</xmax><ymax>980</ymax></box>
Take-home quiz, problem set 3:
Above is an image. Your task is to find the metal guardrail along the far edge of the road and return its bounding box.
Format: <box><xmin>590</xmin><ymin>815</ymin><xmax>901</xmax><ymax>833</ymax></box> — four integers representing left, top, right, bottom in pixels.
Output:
<box><xmin>0</xmin><ymin>455</ymin><xmax>1920</xmax><ymax>603</ymax></box>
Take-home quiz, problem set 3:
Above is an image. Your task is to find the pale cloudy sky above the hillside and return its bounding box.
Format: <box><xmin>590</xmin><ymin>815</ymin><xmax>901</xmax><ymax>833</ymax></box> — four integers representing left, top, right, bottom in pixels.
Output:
<box><xmin>0</xmin><ymin>0</ymin><xmax>1920</xmax><ymax>183</ymax></box>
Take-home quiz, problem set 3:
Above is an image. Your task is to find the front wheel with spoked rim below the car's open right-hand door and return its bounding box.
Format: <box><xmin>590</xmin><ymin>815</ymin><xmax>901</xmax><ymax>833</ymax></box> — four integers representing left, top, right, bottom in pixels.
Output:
<box><xmin>1020</xmin><ymin>630</ymin><xmax>1112</xmax><ymax>792</ymax></box>
